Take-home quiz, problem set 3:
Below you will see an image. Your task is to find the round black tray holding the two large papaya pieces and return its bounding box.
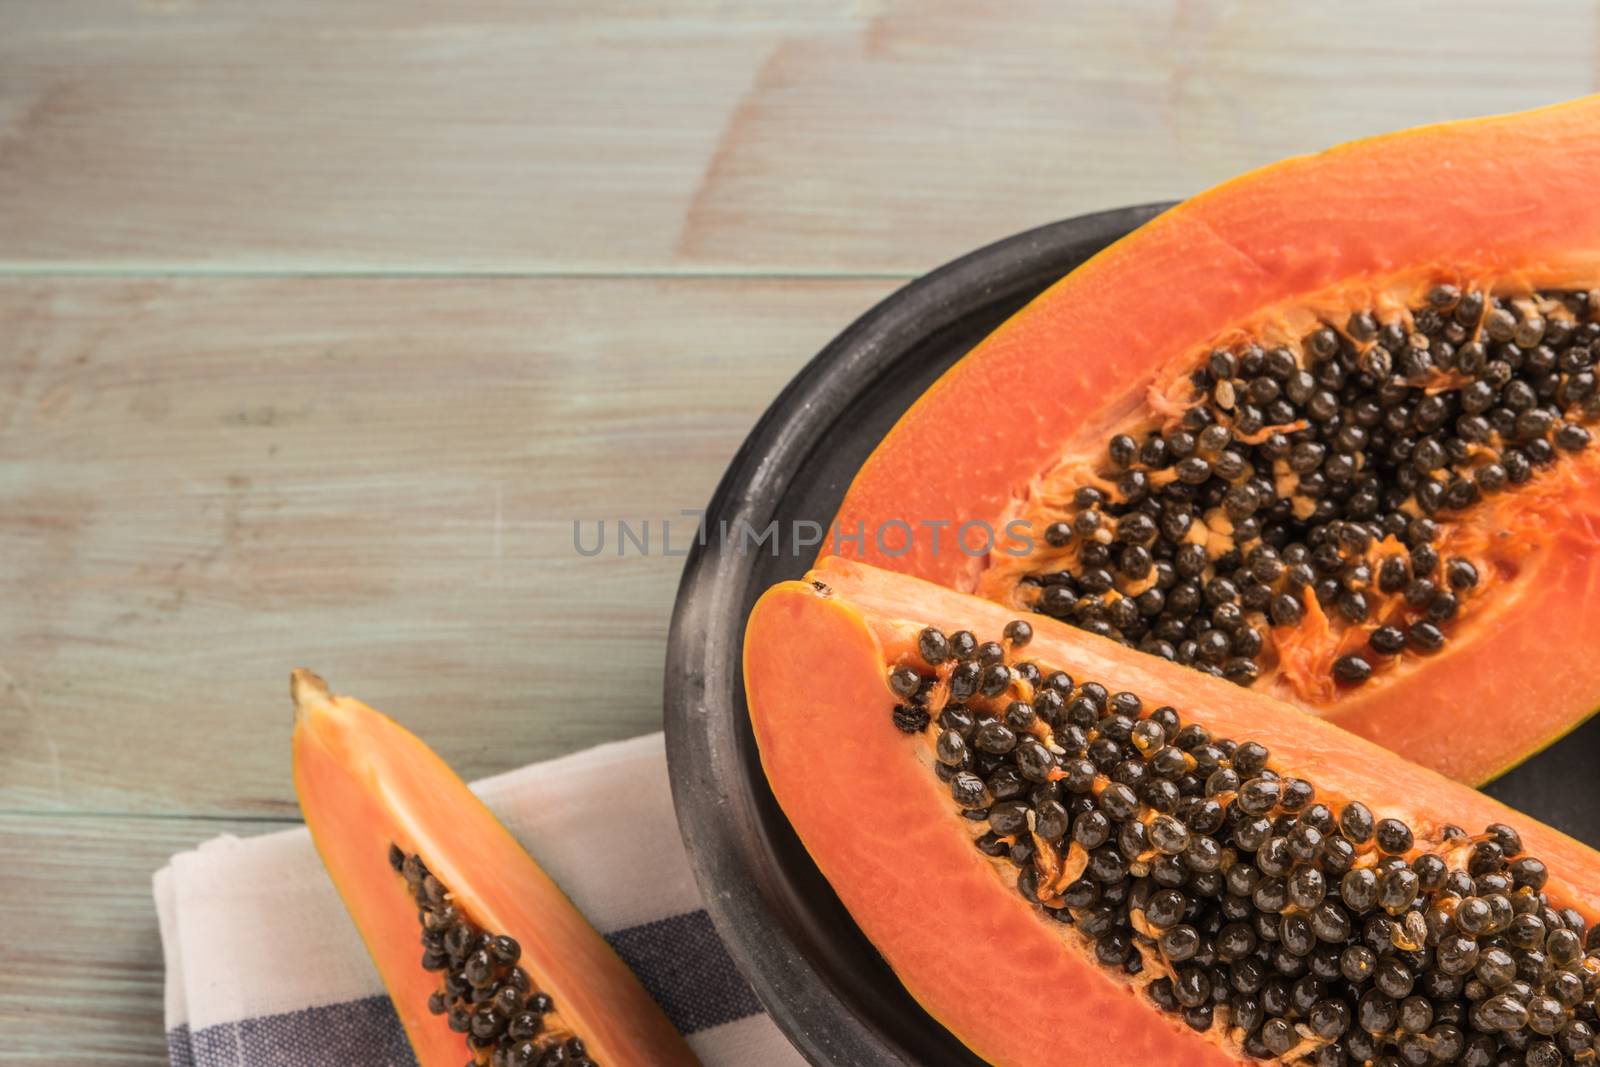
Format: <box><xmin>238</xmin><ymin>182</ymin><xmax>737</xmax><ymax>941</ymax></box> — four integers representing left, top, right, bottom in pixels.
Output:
<box><xmin>666</xmin><ymin>205</ymin><xmax>1600</xmax><ymax>1067</ymax></box>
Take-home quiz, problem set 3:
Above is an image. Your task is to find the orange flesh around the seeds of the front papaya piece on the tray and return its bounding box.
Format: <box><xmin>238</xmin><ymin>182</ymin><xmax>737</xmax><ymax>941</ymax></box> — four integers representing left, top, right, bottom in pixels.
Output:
<box><xmin>744</xmin><ymin>558</ymin><xmax>1600</xmax><ymax>1067</ymax></box>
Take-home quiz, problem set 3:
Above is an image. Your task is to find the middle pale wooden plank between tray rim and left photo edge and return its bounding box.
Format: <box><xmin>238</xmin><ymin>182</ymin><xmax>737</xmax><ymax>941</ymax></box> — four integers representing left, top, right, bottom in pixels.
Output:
<box><xmin>0</xmin><ymin>278</ymin><xmax>893</xmax><ymax>816</ymax></box>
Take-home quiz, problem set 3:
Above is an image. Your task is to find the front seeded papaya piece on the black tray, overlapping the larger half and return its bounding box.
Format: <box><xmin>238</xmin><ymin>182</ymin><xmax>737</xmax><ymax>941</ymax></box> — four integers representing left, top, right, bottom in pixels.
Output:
<box><xmin>744</xmin><ymin>557</ymin><xmax>1600</xmax><ymax>1067</ymax></box>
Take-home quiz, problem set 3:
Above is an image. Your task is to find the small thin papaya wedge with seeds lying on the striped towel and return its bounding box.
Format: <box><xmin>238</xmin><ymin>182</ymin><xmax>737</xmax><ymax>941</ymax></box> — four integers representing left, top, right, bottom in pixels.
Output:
<box><xmin>291</xmin><ymin>670</ymin><xmax>698</xmax><ymax>1067</ymax></box>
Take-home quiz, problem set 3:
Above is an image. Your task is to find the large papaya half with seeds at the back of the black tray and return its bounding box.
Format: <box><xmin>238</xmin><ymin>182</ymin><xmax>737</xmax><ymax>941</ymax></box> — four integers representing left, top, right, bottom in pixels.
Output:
<box><xmin>829</xmin><ymin>98</ymin><xmax>1600</xmax><ymax>782</ymax></box>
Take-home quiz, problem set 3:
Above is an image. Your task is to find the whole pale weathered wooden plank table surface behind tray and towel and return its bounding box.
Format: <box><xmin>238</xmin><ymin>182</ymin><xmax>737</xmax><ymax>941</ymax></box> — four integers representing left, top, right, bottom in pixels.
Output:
<box><xmin>0</xmin><ymin>0</ymin><xmax>1600</xmax><ymax>1064</ymax></box>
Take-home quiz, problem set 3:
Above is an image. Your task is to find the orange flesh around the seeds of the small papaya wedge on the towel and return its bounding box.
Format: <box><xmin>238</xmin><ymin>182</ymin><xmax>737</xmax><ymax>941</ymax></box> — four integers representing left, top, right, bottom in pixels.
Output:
<box><xmin>290</xmin><ymin>670</ymin><xmax>699</xmax><ymax>1067</ymax></box>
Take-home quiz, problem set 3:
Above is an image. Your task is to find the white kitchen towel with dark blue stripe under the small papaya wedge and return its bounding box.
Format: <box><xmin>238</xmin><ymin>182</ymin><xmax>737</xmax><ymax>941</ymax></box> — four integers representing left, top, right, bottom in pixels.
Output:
<box><xmin>155</xmin><ymin>734</ymin><xmax>805</xmax><ymax>1067</ymax></box>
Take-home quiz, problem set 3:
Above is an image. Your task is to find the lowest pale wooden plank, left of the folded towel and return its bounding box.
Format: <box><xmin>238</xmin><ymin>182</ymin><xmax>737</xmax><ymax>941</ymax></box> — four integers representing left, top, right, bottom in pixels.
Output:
<box><xmin>0</xmin><ymin>816</ymin><xmax>300</xmax><ymax>1067</ymax></box>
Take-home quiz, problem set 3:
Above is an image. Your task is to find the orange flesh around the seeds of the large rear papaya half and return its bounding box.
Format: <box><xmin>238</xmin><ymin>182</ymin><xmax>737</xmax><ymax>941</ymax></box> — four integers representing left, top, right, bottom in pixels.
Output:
<box><xmin>824</xmin><ymin>96</ymin><xmax>1600</xmax><ymax>784</ymax></box>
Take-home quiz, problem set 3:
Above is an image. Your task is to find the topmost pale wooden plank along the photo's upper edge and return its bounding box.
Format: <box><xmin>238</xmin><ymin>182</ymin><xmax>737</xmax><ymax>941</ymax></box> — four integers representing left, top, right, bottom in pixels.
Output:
<box><xmin>0</xmin><ymin>0</ymin><xmax>1600</xmax><ymax>274</ymax></box>
